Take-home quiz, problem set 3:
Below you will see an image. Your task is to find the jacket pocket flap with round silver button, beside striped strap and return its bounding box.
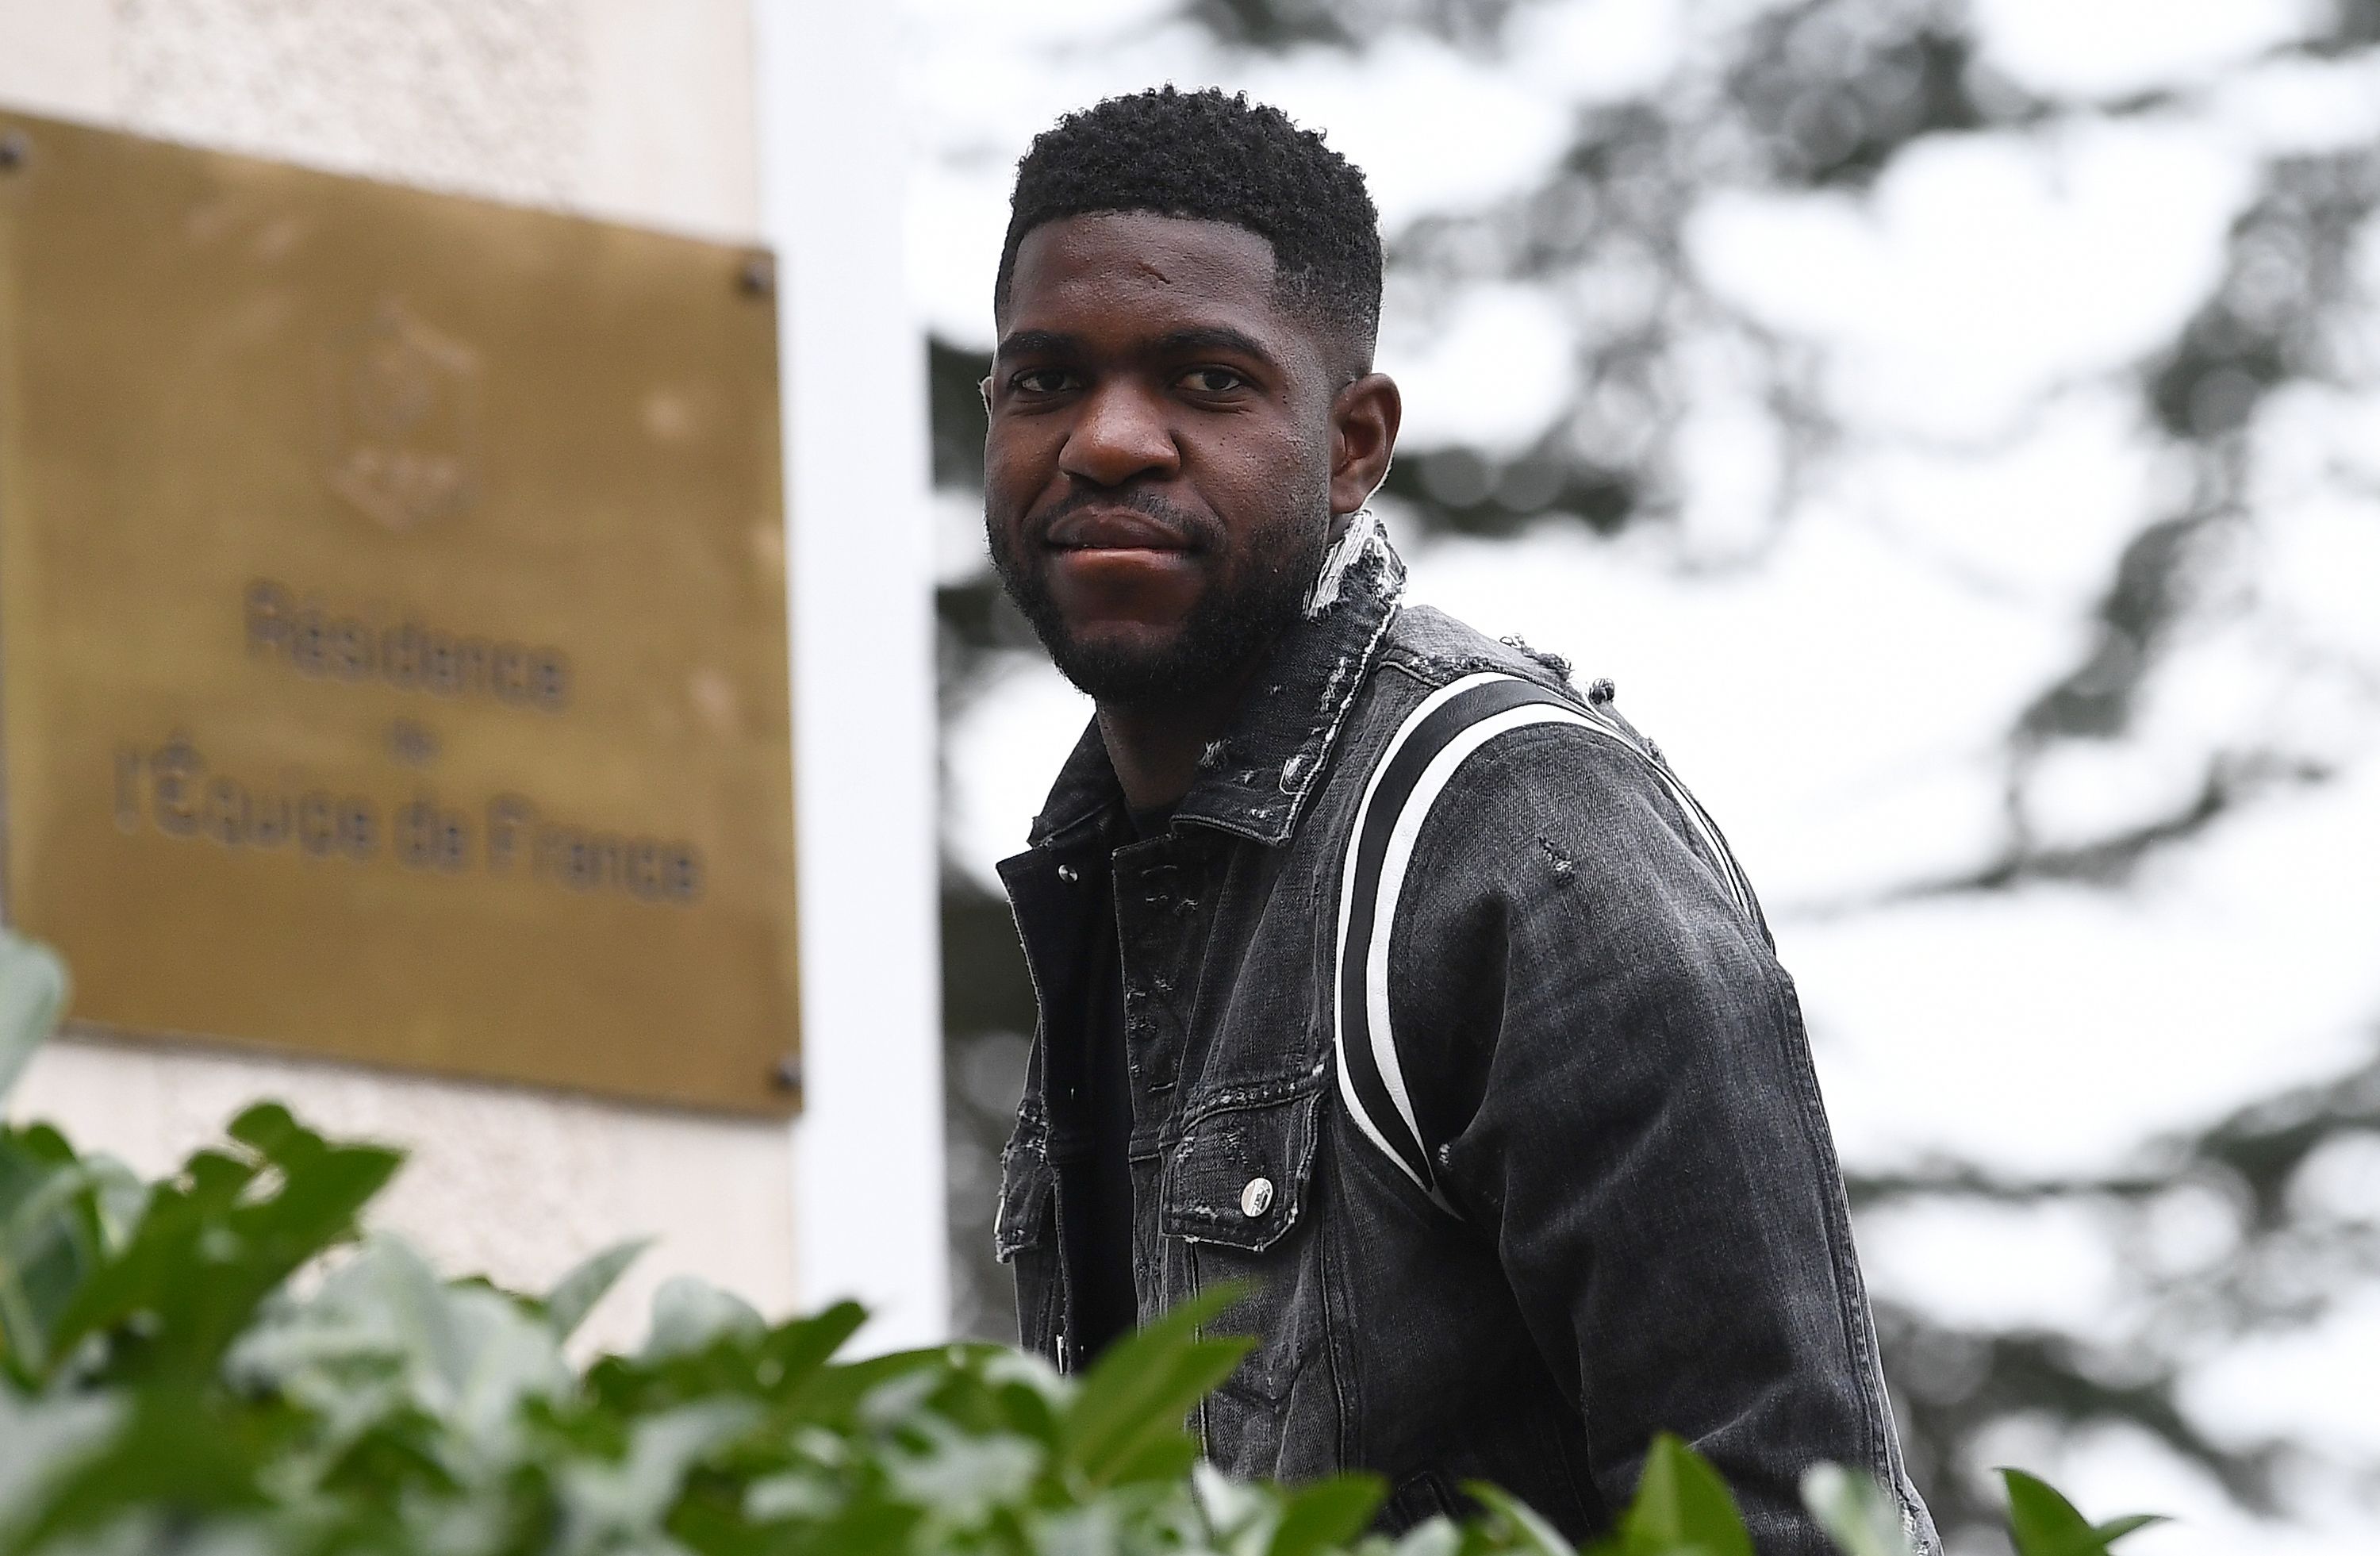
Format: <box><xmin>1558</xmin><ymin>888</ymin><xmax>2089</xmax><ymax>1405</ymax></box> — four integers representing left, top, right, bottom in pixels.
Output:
<box><xmin>1159</xmin><ymin>1089</ymin><xmax>1323</xmax><ymax>1254</ymax></box>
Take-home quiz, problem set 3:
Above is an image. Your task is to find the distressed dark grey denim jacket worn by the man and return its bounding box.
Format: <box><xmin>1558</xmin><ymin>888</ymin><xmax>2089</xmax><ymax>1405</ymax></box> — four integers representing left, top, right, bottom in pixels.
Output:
<box><xmin>997</xmin><ymin>526</ymin><xmax>1935</xmax><ymax>1556</ymax></box>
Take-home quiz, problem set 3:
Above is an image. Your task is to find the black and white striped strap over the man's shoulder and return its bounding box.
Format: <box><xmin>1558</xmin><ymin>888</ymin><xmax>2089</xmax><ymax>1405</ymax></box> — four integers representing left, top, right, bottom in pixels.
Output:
<box><xmin>1333</xmin><ymin>671</ymin><xmax>1754</xmax><ymax>1213</ymax></box>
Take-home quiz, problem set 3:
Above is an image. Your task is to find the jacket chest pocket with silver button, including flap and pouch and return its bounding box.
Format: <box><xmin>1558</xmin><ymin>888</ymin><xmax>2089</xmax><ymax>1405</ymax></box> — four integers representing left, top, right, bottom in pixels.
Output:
<box><xmin>1159</xmin><ymin>1078</ymin><xmax>1340</xmax><ymax>1475</ymax></box>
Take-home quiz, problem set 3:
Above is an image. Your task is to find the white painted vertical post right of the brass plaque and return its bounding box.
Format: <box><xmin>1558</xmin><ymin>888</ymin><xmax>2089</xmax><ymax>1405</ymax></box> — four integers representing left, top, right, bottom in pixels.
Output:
<box><xmin>752</xmin><ymin>0</ymin><xmax>950</xmax><ymax>1349</ymax></box>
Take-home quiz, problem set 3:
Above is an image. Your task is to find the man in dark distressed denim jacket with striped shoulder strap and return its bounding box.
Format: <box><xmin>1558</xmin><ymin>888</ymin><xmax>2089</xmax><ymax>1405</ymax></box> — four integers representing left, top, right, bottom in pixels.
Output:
<box><xmin>983</xmin><ymin>88</ymin><xmax>1933</xmax><ymax>1554</ymax></box>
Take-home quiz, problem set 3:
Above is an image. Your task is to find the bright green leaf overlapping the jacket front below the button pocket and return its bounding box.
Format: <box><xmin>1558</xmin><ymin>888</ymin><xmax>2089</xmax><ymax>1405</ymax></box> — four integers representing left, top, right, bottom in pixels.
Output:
<box><xmin>1064</xmin><ymin>1285</ymin><xmax>1254</xmax><ymax>1485</ymax></box>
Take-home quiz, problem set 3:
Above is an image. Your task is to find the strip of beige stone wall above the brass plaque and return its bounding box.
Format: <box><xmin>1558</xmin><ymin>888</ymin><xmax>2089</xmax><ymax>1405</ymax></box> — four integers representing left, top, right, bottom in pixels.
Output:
<box><xmin>0</xmin><ymin>0</ymin><xmax>759</xmax><ymax>238</ymax></box>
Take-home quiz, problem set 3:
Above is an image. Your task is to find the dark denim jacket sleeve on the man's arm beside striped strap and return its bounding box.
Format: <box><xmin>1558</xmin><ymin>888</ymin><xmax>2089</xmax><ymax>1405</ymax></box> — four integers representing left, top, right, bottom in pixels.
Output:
<box><xmin>1390</xmin><ymin>726</ymin><xmax>1930</xmax><ymax>1556</ymax></box>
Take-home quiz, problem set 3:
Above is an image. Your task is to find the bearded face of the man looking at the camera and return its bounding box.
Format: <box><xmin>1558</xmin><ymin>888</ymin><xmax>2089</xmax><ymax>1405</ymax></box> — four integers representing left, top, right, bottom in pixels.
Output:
<box><xmin>983</xmin><ymin>212</ymin><xmax>1335</xmax><ymax>709</ymax></box>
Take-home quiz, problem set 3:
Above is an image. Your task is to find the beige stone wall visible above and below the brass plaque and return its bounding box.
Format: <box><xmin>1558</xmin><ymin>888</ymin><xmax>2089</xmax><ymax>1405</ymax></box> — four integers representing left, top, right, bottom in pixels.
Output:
<box><xmin>0</xmin><ymin>0</ymin><xmax>795</xmax><ymax>1344</ymax></box>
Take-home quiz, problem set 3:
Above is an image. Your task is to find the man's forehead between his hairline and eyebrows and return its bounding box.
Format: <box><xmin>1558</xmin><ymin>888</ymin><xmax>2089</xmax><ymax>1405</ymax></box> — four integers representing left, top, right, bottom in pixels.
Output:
<box><xmin>1000</xmin><ymin>212</ymin><xmax>1292</xmax><ymax>344</ymax></box>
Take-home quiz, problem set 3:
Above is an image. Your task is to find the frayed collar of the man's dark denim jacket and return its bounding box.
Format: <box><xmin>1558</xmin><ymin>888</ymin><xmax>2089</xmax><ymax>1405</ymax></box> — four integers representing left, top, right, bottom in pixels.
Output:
<box><xmin>1026</xmin><ymin>512</ymin><xmax>1404</xmax><ymax>847</ymax></box>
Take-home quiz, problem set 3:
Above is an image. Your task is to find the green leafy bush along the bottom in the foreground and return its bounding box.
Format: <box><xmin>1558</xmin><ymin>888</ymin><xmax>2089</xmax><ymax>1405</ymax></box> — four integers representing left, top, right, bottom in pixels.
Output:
<box><xmin>0</xmin><ymin>939</ymin><xmax>2144</xmax><ymax>1556</ymax></box>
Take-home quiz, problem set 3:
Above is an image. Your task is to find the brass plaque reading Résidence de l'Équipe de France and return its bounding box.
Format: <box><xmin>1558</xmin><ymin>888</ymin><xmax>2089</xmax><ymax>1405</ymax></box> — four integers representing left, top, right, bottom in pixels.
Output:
<box><xmin>0</xmin><ymin>114</ymin><xmax>797</xmax><ymax>1113</ymax></box>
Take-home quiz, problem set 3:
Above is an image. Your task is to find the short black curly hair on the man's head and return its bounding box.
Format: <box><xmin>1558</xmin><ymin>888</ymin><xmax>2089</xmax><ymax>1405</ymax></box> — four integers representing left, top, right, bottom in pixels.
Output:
<box><xmin>992</xmin><ymin>86</ymin><xmax>1380</xmax><ymax>371</ymax></box>
